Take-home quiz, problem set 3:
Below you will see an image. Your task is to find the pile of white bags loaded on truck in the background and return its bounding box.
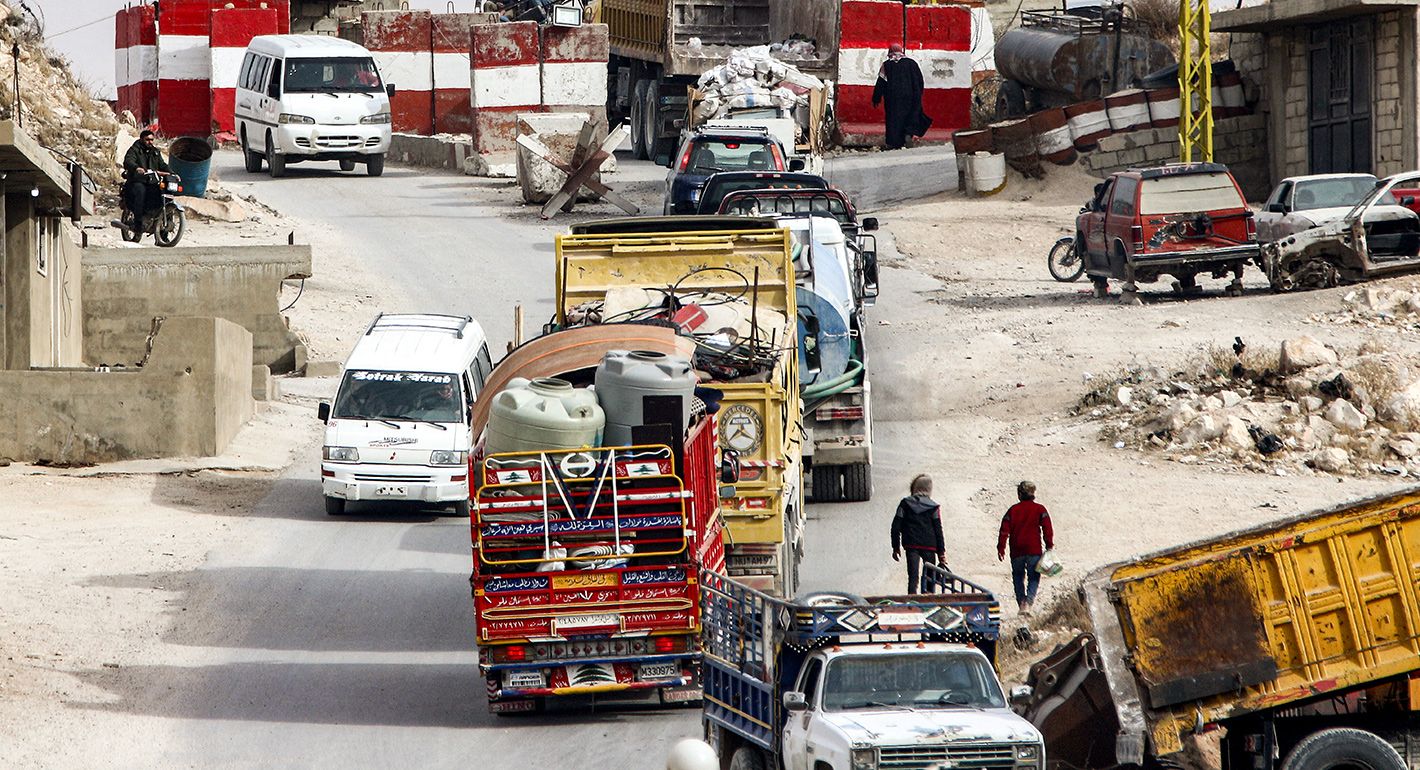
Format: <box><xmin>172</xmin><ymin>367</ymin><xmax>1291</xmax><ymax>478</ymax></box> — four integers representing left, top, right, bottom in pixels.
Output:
<box><xmin>692</xmin><ymin>40</ymin><xmax>824</xmax><ymax>122</ymax></box>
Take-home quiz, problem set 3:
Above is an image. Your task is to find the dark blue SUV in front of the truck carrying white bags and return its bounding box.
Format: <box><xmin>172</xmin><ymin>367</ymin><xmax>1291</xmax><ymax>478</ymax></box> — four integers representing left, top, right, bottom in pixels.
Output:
<box><xmin>663</xmin><ymin>126</ymin><xmax>802</xmax><ymax>215</ymax></box>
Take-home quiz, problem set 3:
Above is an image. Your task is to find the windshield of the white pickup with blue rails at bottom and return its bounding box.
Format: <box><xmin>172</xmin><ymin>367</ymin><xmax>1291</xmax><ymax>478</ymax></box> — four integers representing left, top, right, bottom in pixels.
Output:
<box><xmin>824</xmin><ymin>652</ymin><xmax>1005</xmax><ymax>712</ymax></box>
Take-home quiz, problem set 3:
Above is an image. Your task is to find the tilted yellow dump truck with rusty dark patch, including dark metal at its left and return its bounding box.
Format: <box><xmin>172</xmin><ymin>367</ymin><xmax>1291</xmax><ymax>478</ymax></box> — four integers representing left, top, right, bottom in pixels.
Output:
<box><xmin>1014</xmin><ymin>487</ymin><xmax>1420</xmax><ymax>770</ymax></box>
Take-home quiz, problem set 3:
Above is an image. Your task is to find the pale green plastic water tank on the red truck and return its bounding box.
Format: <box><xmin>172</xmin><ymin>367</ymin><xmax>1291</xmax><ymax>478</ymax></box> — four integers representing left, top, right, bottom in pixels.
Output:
<box><xmin>486</xmin><ymin>376</ymin><xmax>606</xmax><ymax>455</ymax></box>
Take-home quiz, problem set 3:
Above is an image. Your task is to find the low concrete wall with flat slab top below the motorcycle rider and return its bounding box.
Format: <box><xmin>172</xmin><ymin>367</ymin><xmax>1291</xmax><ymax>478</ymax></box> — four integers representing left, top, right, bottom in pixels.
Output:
<box><xmin>84</xmin><ymin>246</ymin><xmax>311</xmax><ymax>372</ymax></box>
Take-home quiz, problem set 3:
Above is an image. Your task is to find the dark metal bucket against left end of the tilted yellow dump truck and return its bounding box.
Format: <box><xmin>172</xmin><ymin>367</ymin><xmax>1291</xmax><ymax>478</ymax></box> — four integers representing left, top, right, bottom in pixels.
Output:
<box><xmin>1015</xmin><ymin>634</ymin><xmax>1119</xmax><ymax>770</ymax></box>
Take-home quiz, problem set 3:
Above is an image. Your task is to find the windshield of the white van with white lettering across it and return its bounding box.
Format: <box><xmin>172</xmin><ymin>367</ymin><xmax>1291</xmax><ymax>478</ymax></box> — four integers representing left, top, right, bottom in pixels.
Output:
<box><xmin>331</xmin><ymin>369</ymin><xmax>464</xmax><ymax>423</ymax></box>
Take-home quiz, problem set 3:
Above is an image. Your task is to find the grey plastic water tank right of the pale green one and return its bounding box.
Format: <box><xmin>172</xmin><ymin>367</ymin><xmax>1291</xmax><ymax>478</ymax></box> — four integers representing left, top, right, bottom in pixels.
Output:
<box><xmin>596</xmin><ymin>351</ymin><xmax>696</xmax><ymax>446</ymax></box>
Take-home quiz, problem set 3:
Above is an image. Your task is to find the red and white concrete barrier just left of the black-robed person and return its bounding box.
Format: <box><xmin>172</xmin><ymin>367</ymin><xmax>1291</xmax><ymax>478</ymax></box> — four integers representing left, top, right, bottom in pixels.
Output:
<box><xmin>834</xmin><ymin>0</ymin><xmax>903</xmax><ymax>145</ymax></box>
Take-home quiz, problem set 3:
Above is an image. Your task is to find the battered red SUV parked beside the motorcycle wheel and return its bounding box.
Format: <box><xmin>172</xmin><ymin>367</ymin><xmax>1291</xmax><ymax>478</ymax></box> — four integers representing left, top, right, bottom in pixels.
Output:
<box><xmin>1075</xmin><ymin>163</ymin><xmax>1258</xmax><ymax>301</ymax></box>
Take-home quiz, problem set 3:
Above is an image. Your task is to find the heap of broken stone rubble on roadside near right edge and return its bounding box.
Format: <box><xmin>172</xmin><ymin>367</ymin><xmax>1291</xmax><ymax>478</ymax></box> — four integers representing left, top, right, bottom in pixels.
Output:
<box><xmin>1076</xmin><ymin>337</ymin><xmax>1420</xmax><ymax>476</ymax></box>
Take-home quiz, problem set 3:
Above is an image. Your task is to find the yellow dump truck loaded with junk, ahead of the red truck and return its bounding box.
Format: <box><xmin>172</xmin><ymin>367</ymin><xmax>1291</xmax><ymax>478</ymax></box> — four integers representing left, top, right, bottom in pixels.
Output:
<box><xmin>552</xmin><ymin>216</ymin><xmax>804</xmax><ymax>597</ymax></box>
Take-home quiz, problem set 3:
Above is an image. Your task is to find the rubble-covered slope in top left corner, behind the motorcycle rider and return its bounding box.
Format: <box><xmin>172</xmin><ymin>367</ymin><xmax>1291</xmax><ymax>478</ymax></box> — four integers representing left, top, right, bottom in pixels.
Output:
<box><xmin>0</xmin><ymin>4</ymin><xmax>119</xmax><ymax>205</ymax></box>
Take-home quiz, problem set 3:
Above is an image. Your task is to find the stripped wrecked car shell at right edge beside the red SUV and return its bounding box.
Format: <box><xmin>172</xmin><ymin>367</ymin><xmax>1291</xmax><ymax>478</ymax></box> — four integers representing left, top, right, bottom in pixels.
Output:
<box><xmin>1262</xmin><ymin>170</ymin><xmax>1420</xmax><ymax>291</ymax></box>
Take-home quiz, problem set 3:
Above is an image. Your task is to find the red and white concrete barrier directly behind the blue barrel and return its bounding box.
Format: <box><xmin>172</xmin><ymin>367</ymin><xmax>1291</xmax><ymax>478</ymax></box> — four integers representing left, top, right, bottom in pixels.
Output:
<box><xmin>158</xmin><ymin>0</ymin><xmax>212</xmax><ymax>136</ymax></box>
